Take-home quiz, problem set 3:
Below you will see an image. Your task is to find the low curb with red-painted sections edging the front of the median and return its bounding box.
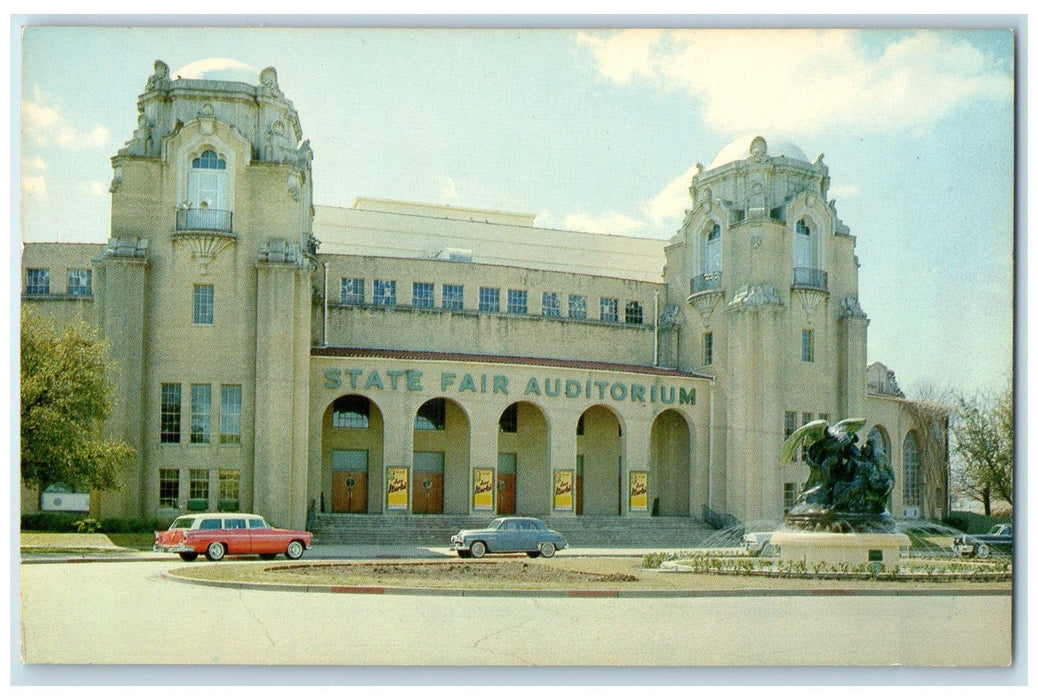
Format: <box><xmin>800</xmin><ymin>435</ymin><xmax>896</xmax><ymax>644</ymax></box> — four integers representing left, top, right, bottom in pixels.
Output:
<box><xmin>161</xmin><ymin>571</ymin><xmax>1013</xmax><ymax>598</ymax></box>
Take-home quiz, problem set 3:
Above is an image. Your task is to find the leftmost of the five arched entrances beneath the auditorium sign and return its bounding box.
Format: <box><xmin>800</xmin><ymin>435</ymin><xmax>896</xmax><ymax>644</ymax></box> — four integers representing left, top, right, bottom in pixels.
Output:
<box><xmin>321</xmin><ymin>394</ymin><xmax>384</xmax><ymax>513</ymax></box>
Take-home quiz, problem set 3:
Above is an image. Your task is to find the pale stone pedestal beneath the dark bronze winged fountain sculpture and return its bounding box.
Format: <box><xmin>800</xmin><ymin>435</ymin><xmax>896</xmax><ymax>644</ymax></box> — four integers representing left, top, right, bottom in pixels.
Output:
<box><xmin>771</xmin><ymin>530</ymin><xmax>910</xmax><ymax>570</ymax></box>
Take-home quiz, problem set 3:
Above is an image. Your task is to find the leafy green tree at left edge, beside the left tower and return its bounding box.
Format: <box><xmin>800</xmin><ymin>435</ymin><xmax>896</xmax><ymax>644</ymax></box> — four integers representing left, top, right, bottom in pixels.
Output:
<box><xmin>21</xmin><ymin>309</ymin><xmax>135</xmax><ymax>490</ymax></box>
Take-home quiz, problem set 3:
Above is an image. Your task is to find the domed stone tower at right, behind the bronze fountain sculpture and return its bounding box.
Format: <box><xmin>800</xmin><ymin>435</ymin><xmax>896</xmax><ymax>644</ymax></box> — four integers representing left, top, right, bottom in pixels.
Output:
<box><xmin>663</xmin><ymin>136</ymin><xmax>868</xmax><ymax>521</ymax></box>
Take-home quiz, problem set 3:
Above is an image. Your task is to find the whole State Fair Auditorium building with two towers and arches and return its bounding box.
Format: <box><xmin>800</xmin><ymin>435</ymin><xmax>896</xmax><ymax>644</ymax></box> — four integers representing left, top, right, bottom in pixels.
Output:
<box><xmin>22</xmin><ymin>61</ymin><xmax>948</xmax><ymax>527</ymax></box>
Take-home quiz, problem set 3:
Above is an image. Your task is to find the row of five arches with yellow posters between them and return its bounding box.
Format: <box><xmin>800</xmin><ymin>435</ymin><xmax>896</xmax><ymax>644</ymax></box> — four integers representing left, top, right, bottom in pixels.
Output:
<box><xmin>319</xmin><ymin>393</ymin><xmax>698</xmax><ymax>516</ymax></box>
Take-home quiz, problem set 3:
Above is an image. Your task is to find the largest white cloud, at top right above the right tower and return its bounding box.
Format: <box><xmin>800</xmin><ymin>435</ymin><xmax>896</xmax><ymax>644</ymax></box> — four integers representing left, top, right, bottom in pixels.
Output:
<box><xmin>577</xmin><ymin>29</ymin><xmax>1013</xmax><ymax>133</ymax></box>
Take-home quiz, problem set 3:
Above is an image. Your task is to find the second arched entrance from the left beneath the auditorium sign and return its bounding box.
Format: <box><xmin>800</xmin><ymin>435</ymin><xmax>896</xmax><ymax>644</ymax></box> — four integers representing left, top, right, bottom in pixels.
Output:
<box><xmin>411</xmin><ymin>398</ymin><xmax>469</xmax><ymax>514</ymax></box>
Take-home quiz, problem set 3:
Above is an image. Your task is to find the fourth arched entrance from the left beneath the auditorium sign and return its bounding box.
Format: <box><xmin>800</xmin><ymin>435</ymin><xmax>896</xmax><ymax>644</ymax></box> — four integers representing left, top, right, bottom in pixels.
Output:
<box><xmin>574</xmin><ymin>405</ymin><xmax>624</xmax><ymax>515</ymax></box>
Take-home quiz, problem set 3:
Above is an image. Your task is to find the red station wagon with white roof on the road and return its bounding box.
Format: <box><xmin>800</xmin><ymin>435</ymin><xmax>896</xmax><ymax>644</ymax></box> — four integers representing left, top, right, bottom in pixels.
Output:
<box><xmin>153</xmin><ymin>513</ymin><xmax>313</xmax><ymax>562</ymax></box>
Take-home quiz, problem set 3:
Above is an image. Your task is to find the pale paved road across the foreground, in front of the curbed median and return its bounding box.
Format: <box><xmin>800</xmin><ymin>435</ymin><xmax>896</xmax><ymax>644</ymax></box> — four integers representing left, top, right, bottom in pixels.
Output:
<box><xmin>21</xmin><ymin>560</ymin><xmax>1012</xmax><ymax>666</ymax></box>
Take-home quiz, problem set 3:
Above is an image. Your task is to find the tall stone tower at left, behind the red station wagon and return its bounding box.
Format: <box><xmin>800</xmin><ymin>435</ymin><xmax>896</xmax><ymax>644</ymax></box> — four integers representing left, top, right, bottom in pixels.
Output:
<box><xmin>94</xmin><ymin>61</ymin><xmax>317</xmax><ymax>526</ymax></box>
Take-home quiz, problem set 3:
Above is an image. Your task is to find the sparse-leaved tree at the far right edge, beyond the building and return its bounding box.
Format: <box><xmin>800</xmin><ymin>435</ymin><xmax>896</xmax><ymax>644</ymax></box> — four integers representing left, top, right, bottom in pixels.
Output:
<box><xmin>952</xmin><ymin>385</ymin><xmax>1013</xmax><ymax>515</ymax></box>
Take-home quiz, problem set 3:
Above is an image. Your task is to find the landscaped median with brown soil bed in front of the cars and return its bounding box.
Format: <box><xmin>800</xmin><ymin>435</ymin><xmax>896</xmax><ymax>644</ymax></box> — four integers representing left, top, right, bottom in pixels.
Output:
<box><xmin>165</xmin><ymin>557</ymin><xmax>1012</xmax><ymax>597</ymax></box>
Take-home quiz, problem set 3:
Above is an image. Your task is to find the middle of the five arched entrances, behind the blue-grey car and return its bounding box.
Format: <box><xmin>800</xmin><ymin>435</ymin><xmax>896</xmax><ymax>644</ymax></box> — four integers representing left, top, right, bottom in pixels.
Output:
<box><xmin>497</xmin><ymin>401</ymin><xmax>551</xmax><ymax>515</ymax></box>
